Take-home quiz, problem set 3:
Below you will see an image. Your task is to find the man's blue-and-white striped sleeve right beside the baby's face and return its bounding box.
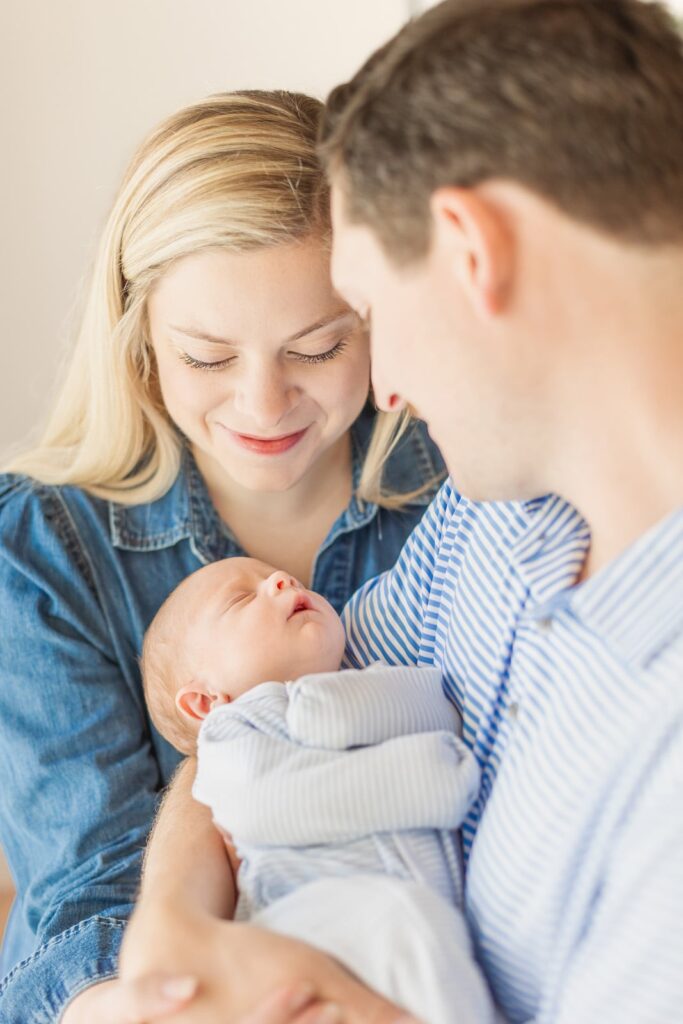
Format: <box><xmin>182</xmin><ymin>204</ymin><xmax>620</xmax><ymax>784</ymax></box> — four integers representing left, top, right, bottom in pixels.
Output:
<box><xmin>342</xmin><ymin>480</ymin><xmax>458</xmax><ymax>669</ymax></box>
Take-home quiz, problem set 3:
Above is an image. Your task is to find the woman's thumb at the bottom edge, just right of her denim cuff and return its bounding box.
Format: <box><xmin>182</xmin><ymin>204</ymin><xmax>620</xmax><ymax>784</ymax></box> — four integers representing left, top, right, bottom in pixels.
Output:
<box><xmin>98</xmin><ymin>974</ymin><xmax>197</xmax><ymax>1024</ymax></box>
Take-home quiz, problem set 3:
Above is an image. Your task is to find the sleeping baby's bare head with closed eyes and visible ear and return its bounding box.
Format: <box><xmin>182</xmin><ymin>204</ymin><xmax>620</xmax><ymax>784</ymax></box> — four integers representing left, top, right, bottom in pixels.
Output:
<box><xmin>141</xmin><ymin>558</ymin><xmax>344</xmax><ymax>754</ymax></box>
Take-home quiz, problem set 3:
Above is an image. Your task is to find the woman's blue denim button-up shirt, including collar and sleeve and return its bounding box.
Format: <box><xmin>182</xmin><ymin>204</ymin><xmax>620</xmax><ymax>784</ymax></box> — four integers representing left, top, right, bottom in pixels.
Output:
<box><xmin>0</xmin><ymin>410</ymin><xmax>442</xmax><ymax>1024</ymax></box>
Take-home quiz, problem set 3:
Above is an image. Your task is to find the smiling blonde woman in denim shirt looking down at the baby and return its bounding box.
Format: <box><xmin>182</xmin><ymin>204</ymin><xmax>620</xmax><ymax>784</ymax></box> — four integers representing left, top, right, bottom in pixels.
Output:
<box><xmin>0</xmin><ymin>92</ymin><xmax>441</xmax><ymax>1022</ymax></box>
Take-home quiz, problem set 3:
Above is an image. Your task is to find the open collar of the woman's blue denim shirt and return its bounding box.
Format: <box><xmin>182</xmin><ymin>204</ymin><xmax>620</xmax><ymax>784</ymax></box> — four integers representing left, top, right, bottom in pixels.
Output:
<box><xmin>109</xmin><ymin>406</ymin><xmax>441</xmax><ymax>561</ymax></box>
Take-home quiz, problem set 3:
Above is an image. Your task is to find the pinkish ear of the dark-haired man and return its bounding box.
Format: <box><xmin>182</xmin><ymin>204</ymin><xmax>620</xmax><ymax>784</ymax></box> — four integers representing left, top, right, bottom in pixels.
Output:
<box><xmin>430</xmin><ymin>186</ymin><xmax>513</xmax><ymax>316</ymax></box>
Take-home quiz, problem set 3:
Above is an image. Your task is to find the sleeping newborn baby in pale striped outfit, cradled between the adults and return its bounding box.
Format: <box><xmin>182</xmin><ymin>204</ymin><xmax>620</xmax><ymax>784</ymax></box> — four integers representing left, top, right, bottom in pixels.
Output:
<box><xmin>142</xmin><ymin>558</ymin><xmax>489</xmax><ymax>1024</ymax></box>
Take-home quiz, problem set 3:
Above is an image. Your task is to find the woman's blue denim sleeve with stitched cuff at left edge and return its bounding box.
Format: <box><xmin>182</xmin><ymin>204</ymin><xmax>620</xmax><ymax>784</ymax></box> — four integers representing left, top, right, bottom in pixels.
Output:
<box><xmin>0</xmin><ymin>485</ymin><xmax>160</xmax><ymax>1024</ymax></box>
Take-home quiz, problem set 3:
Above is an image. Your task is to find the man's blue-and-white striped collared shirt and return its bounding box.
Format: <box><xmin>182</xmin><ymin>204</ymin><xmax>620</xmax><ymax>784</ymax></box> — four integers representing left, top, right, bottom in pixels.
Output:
<box><xmin>345</xmin><ymin>482</ymin><xmax>683</xmax><ymax>1024</ymax></box>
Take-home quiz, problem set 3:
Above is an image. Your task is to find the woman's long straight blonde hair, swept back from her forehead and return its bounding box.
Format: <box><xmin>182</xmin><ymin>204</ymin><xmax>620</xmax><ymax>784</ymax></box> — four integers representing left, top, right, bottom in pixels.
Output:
<box><xmin>5</xmin><ymin>91</ymin><xmax>431</xmax><ymax>506</ymax></box>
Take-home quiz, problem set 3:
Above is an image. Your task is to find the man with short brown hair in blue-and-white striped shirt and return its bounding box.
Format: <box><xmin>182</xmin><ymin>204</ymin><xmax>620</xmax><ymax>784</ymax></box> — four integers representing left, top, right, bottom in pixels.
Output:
<box><xmin>323</xmin><ymin>0</ymin><xmax>683</xmax><ymax>1024</ymax></box>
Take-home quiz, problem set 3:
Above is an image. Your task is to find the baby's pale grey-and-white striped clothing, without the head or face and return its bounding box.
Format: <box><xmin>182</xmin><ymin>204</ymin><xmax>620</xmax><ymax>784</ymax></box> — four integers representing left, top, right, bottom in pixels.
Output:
<box><xmin>194</xmin><ymin>665</ymin><xmax>497</xmax><ymax>1024</ymax></box>
